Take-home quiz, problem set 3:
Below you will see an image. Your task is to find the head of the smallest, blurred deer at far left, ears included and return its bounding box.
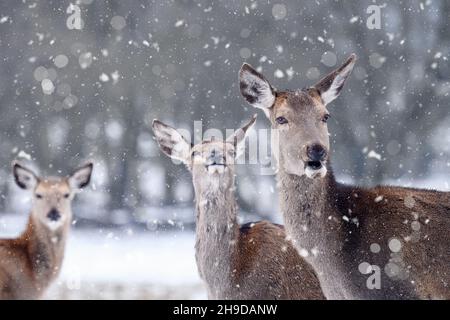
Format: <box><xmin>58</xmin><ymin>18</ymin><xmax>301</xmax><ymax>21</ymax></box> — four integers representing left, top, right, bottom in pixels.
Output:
<box><xmin>13</xmin><ymin>162</ymin><xmax>93</xmax><ymax>230</ymax></box>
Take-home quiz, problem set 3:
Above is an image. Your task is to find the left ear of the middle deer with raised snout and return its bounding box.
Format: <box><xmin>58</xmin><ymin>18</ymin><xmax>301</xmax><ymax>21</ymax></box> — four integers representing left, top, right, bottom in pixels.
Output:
<box><xmin>152</xmin><ymin>120</ymin><xmax>191</xmax><ymax>164</ymax></box>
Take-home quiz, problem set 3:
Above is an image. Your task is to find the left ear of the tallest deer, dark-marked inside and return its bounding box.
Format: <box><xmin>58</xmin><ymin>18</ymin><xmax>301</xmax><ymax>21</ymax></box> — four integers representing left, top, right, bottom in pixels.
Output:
<box><xmin>239</xmin><ymin>63</ymin><xmax>275</xmax><ymax>114</ymax></box>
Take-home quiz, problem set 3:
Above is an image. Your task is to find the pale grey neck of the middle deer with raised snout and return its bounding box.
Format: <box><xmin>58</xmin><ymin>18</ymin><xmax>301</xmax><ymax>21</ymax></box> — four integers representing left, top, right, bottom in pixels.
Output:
<box><xmin>195</xmin><ymin>180</ymin><xmax>243</xmax><ymax>296</ymax></box>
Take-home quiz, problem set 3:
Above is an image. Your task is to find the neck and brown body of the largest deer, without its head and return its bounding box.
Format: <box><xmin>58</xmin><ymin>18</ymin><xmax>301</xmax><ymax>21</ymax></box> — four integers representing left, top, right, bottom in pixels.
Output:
<box><xmin>279</xmin><ymin>170</ymin><xmax>450</xmax><ymax>299</ymax></box>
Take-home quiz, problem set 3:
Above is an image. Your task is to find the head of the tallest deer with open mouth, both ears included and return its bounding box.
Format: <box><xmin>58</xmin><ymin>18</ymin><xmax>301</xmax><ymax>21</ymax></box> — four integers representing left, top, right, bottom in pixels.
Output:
<box><xmin>239</xmin><ymin>54</ymin><xmax>356</xmax><ymax>178</ymax></box>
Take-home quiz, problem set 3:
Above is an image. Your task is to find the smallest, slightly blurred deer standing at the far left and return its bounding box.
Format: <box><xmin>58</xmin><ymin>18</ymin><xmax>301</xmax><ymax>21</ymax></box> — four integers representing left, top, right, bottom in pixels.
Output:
<box><xmin>0</xmin><ymin>163</ymin><xmax>93</xmax><ymax>299</ymax></box>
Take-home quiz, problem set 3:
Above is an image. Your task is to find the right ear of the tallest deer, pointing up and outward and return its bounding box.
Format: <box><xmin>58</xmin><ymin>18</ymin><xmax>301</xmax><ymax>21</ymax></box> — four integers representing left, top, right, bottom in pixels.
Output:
<box><xmin>314</xmin><ymin>53</ymin><xmax>356</xmax><ymax>105</ymax></box>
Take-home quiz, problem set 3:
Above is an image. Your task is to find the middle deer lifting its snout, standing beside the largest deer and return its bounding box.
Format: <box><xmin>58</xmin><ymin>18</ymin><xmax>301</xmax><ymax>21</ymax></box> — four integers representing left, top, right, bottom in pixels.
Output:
<box><xmin>153</xmin><ymin>118</ymin><xmax>323</xmax><ymax>299</ymax></box>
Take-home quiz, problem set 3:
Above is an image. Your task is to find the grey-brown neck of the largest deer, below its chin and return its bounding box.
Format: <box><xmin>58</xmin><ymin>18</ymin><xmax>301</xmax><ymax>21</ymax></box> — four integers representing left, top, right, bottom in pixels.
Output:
<box><xmin>278</xmin><ymin>158</ymin><xmax>347</xmax><ymax>274</ymax></box>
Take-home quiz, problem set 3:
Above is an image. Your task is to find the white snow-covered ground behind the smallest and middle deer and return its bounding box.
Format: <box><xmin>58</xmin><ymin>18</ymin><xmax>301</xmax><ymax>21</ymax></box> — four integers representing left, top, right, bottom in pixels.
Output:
<box><xmin>0</xmin><ymin>215</ymin><xmax>206</xmax><ymax>299</ymax></box>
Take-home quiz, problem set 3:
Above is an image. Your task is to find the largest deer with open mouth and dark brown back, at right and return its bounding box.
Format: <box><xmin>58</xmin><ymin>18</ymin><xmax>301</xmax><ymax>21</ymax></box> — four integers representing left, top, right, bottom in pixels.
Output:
<box><xmin>240</xmin><ymin>55</ymin><xmax>450</xmax><ymax>299</ymax></box>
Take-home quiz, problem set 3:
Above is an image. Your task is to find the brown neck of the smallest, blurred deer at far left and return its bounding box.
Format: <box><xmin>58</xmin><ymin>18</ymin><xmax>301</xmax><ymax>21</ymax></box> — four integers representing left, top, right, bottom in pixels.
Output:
<box><xmin>22</xmin><ymin>214</ymin><xmax>70</xmax><ymax>289</ymax></box>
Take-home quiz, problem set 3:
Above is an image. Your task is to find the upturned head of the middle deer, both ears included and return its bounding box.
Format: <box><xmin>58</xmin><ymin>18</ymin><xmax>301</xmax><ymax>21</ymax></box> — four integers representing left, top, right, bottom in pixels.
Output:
<box><xmin>153</xmin><ymin>116</ymin><xmax>256</xmax><ymax>191</ymax></box>
